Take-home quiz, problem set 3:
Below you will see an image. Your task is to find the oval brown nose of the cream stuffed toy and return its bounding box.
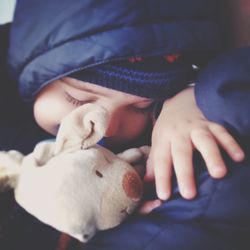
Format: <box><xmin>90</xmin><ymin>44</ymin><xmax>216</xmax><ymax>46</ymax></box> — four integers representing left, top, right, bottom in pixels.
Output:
<box><xmin>122</xmin><ymin>171</ymin><xmax>143</xmax><ymax>201</ymax></box>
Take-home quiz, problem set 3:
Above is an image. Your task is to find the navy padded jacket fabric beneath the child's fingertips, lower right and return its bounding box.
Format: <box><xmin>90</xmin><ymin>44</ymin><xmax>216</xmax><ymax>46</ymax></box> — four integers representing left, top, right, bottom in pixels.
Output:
<box><xmin>82</xmin><ymin>153</ymin><xmax>250</xmax><ymax>250</ymax></box>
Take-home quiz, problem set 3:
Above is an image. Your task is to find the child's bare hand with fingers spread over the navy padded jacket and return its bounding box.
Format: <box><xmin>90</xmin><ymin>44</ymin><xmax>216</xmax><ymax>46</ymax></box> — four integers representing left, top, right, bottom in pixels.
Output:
<box><xmin>145</xmin><ymin>88</ymin><xmax>244</xmax><ymax>200</ymax></box>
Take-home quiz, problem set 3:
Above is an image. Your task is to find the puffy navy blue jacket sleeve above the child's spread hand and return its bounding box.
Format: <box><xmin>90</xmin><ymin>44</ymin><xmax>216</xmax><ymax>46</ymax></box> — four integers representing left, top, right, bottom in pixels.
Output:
<box><xmin>195</xmin><ymin>47</ymin><xmax>250</xmax><ymax>136</ymax></box>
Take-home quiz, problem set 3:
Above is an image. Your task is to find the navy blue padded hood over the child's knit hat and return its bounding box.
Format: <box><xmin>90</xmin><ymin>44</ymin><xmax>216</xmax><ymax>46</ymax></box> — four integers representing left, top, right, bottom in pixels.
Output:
<box><xmin>8</xmin><ymin>0</ymin><xmax>221</xmax><ymax>102</ymax></box>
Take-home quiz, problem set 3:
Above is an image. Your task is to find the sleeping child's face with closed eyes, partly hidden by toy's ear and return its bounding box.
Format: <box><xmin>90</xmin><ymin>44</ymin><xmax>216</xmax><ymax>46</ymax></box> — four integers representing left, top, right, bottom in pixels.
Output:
<box><xmin>34</xmin><ymin>77</ymin><xmax>153</xmax><ymax>145</ymax></box>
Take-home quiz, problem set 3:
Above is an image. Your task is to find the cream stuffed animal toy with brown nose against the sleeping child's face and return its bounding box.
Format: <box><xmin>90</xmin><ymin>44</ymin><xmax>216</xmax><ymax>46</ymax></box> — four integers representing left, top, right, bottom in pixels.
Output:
<box><xmin>0</xmin><ymin>104</ymin><xmax>149</xmax><ymax>242</ymax></box>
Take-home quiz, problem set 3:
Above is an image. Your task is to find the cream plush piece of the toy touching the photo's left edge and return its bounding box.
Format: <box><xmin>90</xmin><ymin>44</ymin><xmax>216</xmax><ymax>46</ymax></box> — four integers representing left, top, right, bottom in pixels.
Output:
<box><xmin>0</xmin><ymin>150</ymin><xmax>23</xmax><ymax>192</ymax></box>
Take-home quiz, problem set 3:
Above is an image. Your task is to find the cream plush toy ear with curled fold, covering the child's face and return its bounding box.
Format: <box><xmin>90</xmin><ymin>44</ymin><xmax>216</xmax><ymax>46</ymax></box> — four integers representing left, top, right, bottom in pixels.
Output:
<box><xmin>54</xmin><ymin>103</ymin><xmax>109</xmax><ymax>154</ymax></box>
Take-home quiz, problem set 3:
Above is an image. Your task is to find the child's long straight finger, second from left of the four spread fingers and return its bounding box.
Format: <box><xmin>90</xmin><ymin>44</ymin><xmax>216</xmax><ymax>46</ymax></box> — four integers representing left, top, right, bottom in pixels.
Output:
<box><xmin>171</xmin><ymin>138</ymin><xmax>196</xmax><ymax>199</ymax></box>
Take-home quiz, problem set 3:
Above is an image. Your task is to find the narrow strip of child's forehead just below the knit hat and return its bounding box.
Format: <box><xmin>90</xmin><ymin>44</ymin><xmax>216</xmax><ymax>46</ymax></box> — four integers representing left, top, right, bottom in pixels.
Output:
<box><xmin>61</xmin><ymin>77</ymin><xmax>151</xmax><ymax>102</ymax></box>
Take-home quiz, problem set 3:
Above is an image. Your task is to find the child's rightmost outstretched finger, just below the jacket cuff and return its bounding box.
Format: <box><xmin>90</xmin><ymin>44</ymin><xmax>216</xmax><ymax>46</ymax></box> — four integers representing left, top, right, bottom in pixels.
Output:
<box><xmin>209</xmin><ymin>123</ymin><xmax>245</xmax><ymax>162</ymax></box>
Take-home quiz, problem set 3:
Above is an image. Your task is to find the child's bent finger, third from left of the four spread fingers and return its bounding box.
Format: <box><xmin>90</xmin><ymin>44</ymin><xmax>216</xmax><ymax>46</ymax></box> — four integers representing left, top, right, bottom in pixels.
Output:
<box><xmin>191</xmin><ymin>129</ymin><xmax>227</xmax><ymax>178</ymax></box>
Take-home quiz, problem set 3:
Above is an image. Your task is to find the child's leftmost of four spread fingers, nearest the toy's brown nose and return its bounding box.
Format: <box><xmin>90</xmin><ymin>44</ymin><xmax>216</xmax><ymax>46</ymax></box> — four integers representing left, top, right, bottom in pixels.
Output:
<box><xmin>153</xmin><ymin>144</ymin><xmax>172</xmax><ymax>200</ymax></box>
